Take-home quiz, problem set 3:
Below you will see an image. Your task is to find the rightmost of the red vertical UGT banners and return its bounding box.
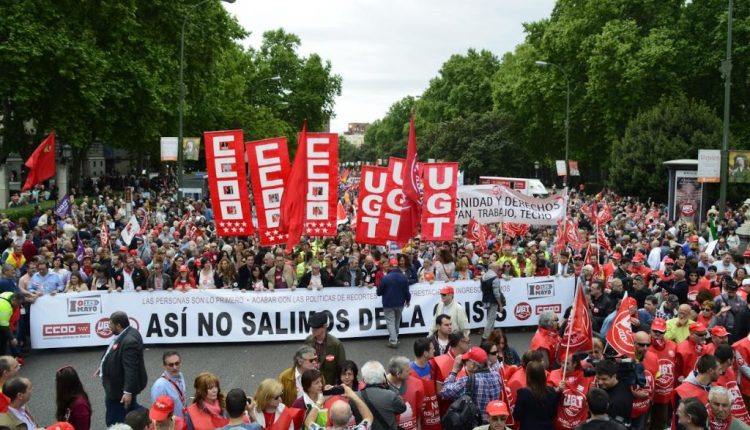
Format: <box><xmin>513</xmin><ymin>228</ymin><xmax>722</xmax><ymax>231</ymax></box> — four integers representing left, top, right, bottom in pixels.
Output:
<box><xmin>422</xmin><ymin>163</ymin><xmax>458</xmax><ymax>241</ymax></box>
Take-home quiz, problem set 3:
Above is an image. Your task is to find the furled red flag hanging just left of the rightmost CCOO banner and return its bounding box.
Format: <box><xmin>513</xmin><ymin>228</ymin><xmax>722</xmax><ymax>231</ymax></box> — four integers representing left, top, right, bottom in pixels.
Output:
<box><xmin>279</xmin><ymin>120</ymin><xmax>307</xmax><ymax>254</ymax></box>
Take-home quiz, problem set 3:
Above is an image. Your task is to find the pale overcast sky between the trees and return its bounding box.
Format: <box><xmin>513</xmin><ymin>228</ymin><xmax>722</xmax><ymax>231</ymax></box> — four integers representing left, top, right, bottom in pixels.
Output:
<box><xmin>223</xmin><ymin>0</ymin><xmax>555</xmax><ymax>132</ymax></box>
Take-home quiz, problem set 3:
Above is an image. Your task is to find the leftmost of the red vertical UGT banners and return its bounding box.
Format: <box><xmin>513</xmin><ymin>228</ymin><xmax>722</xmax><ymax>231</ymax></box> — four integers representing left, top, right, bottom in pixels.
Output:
<box><xmin>356</xmin><ymin>166</ymin><xmax>388</xmax><ymax>245</ymax></box>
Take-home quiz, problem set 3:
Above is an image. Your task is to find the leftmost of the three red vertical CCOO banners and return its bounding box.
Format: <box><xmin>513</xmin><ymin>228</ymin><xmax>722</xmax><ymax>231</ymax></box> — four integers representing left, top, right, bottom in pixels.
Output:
<box><xmin>203</xmin><ymin>130</ymin><xmax>255</xmax><ymax>236</ymax></box>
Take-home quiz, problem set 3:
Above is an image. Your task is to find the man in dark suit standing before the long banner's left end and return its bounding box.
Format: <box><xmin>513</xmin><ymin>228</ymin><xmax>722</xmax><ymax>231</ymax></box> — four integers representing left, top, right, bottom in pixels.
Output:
<box><xmin>98</xmin><ymin>311</ymin><xmax>148</xmax><ymax>426</ymax></box>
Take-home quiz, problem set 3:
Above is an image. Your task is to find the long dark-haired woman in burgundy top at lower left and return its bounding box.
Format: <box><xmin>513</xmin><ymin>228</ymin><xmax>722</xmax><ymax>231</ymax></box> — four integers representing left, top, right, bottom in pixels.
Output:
<box><xmin>55</xmin><ymin>366</ymin><xmax>91</xmax><ymax>430</ymax></box>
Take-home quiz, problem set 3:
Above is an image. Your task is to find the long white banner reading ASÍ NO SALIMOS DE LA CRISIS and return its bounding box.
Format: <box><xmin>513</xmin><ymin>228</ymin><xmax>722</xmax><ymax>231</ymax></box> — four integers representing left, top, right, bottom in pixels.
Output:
<box><xmin>26</xmin><ymin>277</ymin><xmax>574</xmax><ymax>349</ymax></box>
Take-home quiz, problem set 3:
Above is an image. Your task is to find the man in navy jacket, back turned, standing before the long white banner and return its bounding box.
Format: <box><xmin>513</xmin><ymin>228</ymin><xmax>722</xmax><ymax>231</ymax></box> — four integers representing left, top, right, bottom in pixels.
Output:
<box><xmin>377</xmin><ymin>258</ymin><xmax>411</xmax><ymax>349</ymax></box>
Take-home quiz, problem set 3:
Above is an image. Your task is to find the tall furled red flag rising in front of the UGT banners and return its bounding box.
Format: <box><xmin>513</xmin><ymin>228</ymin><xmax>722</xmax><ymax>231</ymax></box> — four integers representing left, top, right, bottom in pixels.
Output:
<box><xmin>397</xmin><ymin>113</ymin><xmax>422</xmax><ymax>244</ymax></box>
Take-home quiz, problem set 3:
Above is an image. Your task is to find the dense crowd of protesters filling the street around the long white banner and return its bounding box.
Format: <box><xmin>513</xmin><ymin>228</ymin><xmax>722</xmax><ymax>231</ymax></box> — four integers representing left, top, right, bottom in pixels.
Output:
<box><xmin>0</xmin><ymin>170</ymin><xmax>750</xmax><ymax>430</ymax></box>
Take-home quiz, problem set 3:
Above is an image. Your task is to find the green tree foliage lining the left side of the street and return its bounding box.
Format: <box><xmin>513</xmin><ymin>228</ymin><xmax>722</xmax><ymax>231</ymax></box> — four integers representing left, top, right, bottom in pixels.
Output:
<box><xmin>0</xmin><ymin>0</ymin><xmax>341</xmax><ymax>176</ymax></box>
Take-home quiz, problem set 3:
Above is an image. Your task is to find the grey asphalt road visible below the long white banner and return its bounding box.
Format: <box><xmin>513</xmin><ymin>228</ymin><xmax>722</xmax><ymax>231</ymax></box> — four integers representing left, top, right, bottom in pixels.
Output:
<box><xmin>21</xmin><ymin>330</ymin><xmax>534</xmax><ymax>430</ymax></box>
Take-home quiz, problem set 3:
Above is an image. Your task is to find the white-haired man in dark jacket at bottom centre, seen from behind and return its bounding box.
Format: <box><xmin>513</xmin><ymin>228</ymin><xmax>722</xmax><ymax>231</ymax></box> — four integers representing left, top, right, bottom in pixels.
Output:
<box><xmin>358</xmin><ymin>360</ymin><xmax>406</xmax><ymax>430</ymax></box>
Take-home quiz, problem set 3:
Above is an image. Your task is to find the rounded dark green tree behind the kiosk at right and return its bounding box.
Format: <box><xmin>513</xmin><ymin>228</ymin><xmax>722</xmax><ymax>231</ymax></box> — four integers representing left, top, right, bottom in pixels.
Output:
<box><xmin>610</xmin><ymin>96</ymin><xmax>721</xmax><ymax>201</ymax></box>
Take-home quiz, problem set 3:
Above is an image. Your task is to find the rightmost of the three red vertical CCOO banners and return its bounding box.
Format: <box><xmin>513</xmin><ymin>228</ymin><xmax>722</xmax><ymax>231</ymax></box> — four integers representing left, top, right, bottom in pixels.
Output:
<box><xmin>306</xmin><ymin>133</ymin><xmax>339</xmax><ymax>236</ymax></box>
